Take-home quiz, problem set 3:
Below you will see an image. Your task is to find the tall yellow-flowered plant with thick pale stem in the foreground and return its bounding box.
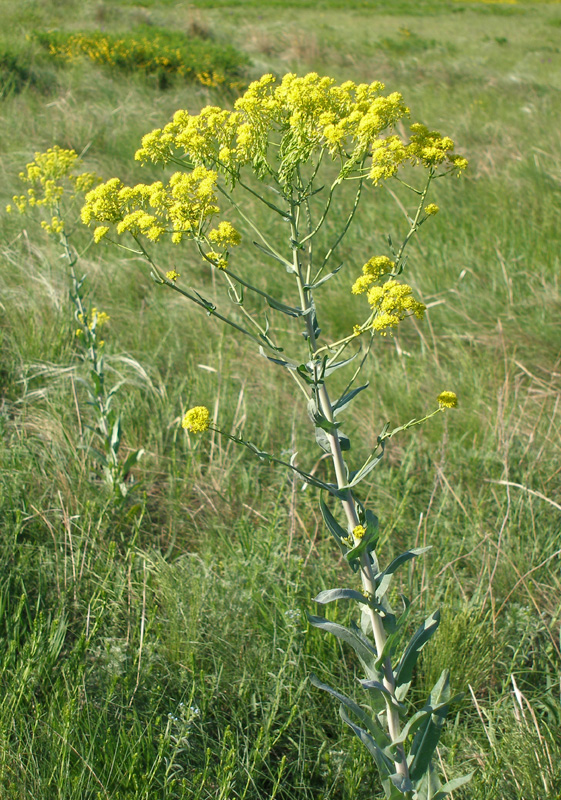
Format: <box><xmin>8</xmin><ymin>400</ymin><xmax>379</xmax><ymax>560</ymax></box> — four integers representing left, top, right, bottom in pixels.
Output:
<box><xmin>82</xmin><ymin>73</ymin><xmax>469</xmax><ymax>800</ymax></box>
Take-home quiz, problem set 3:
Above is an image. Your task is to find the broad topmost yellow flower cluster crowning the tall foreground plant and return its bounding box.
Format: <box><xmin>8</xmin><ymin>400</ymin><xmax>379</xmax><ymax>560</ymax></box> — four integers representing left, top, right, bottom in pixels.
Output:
<box><xmin>135</xmin><ymin>72</ymin><xmax>467</xmax><ymax>183</ymax></box>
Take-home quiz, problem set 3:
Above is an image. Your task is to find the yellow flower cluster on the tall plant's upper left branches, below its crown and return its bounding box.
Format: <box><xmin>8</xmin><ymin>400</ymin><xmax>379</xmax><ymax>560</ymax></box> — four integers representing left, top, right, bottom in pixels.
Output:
<box><xmin>82</xmin><ymin>166</ymin><xmax>241</xmax><ymax>247</ymax></box>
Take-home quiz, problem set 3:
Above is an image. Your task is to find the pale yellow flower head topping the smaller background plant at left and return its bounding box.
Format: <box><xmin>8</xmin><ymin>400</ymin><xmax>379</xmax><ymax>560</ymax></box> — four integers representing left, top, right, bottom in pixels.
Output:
<box><xmin>6</xmin><ymin>145</ymin><xmax>99</xmax><ymax>222</ymax></box>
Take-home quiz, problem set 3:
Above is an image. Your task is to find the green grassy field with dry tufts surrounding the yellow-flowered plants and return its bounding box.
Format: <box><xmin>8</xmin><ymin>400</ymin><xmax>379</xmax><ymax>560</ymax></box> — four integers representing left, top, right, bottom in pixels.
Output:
<box><xmin>0</xmin><ymin>0</ymin><xmax>561</xmax><ymax>800</ymax></box>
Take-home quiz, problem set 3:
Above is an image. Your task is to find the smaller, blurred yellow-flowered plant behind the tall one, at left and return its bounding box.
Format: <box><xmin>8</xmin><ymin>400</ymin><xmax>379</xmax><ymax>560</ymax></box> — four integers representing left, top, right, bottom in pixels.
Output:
<box><xmin>6</xmin><ymin>145</ymin><xmax>144</xmax><ymax>500</ymax></box>
